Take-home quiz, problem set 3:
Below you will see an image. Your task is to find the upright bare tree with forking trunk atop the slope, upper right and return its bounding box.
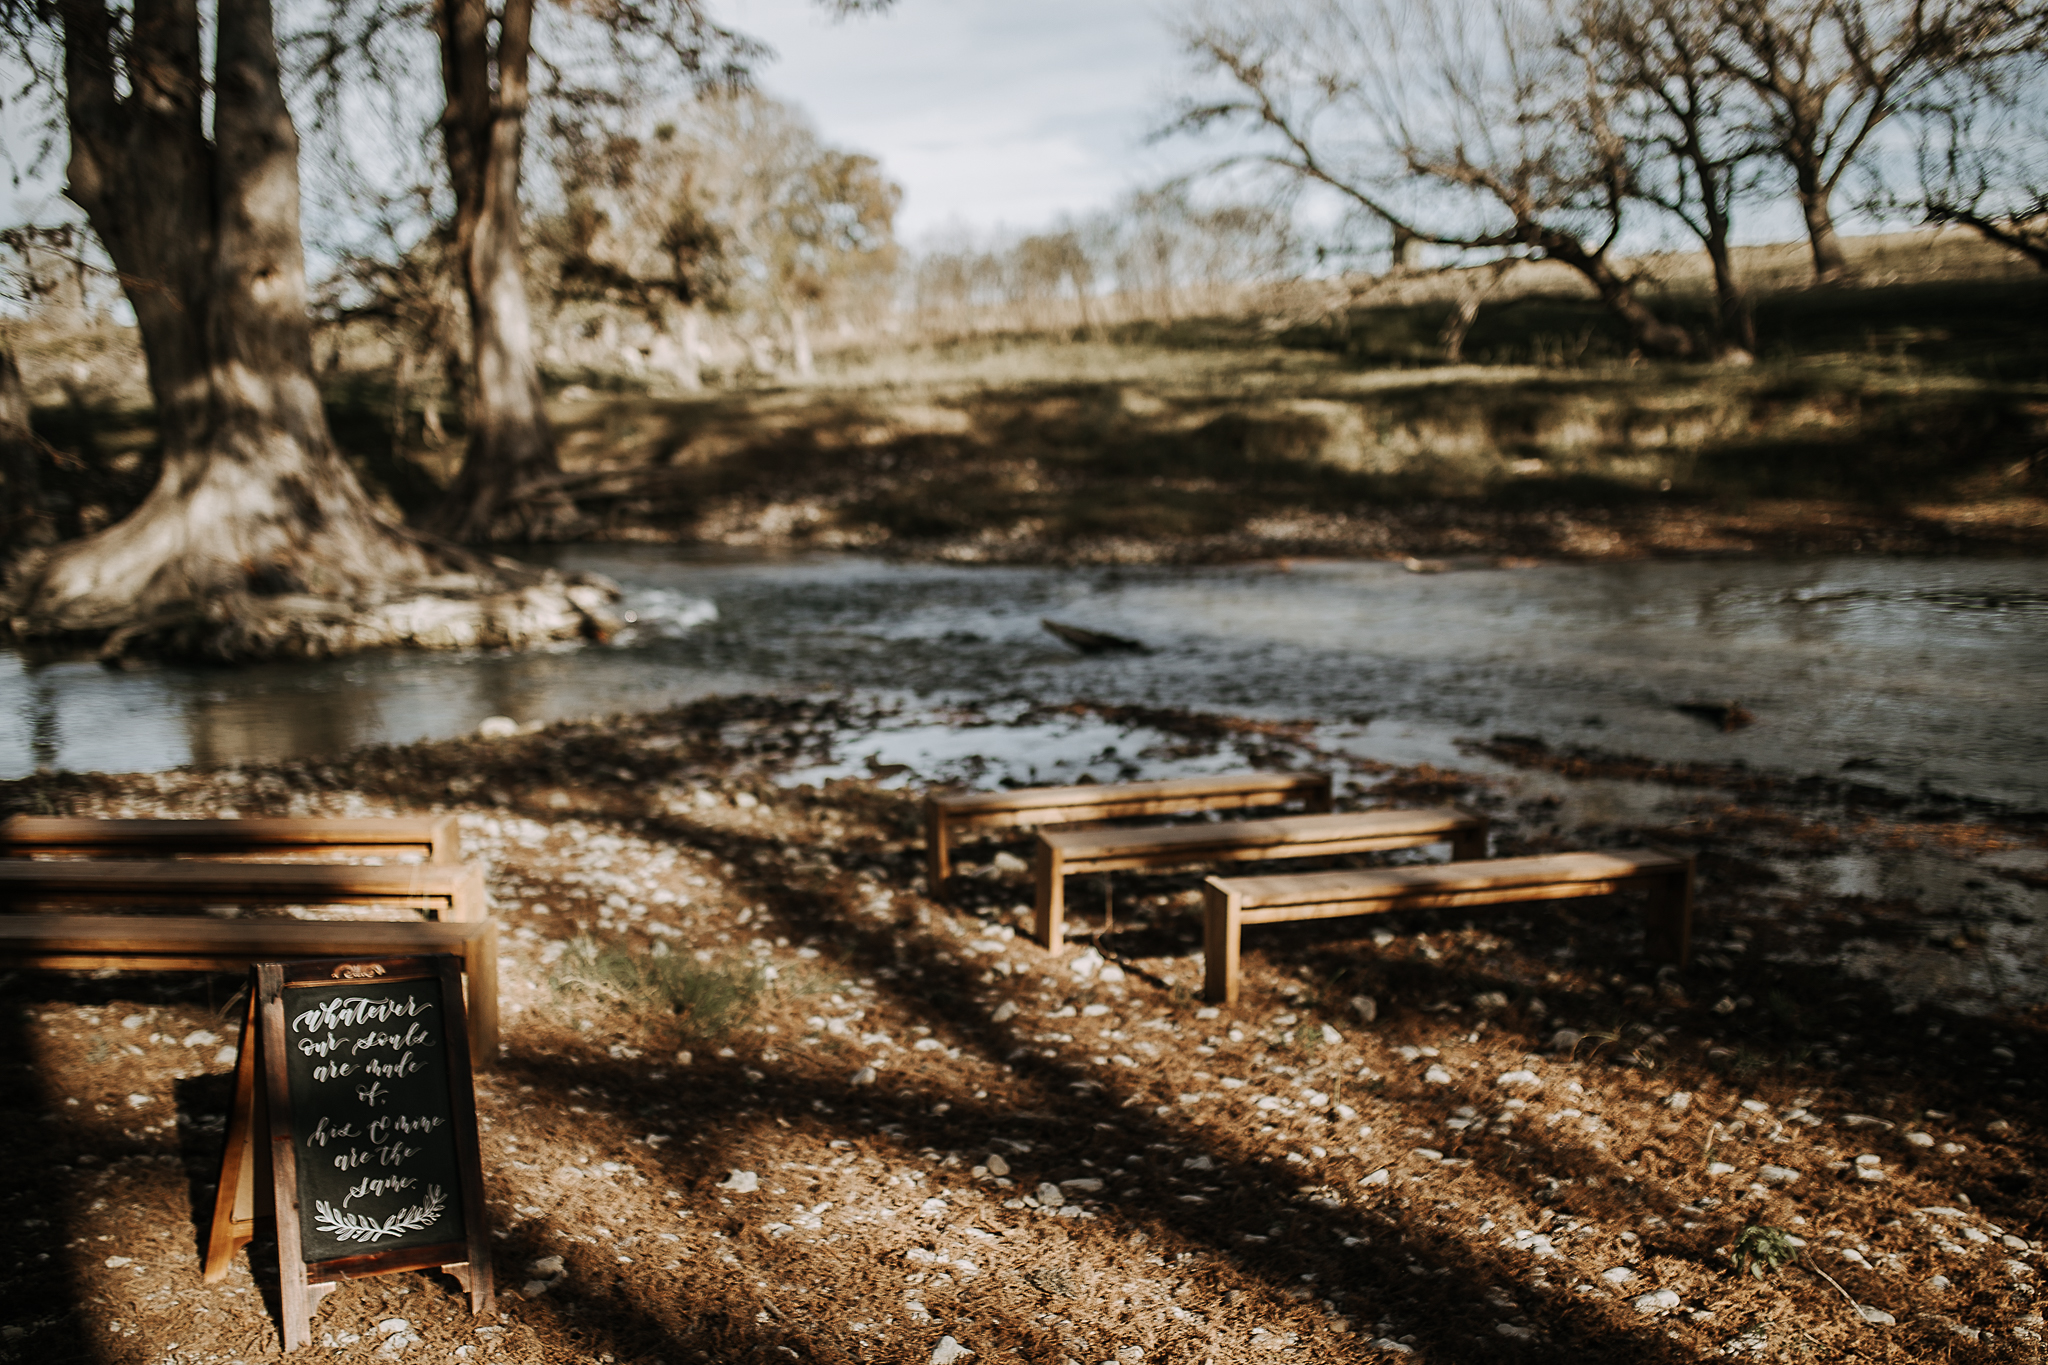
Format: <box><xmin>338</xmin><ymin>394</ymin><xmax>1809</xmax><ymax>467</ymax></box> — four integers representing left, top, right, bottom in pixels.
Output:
<box><xmin>1714</xmin><ymin>0</ymin><xmax>2048</xmax><ymax>284</ymax></box>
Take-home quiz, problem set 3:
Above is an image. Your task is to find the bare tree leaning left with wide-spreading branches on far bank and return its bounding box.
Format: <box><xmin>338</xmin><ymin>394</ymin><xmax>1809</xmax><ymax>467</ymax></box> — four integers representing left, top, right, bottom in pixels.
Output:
<box><xmin>1174</xmin><ymin>0</ymin><xmax>1696</xmax><ymax>358</ymax></box>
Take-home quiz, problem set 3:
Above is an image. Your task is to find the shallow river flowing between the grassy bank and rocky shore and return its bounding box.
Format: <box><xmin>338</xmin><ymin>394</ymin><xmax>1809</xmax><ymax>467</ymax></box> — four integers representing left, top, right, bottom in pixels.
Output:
<box><xmin>0</xmin><ymin>546</ymin><xmax>2048</xmax><ymax>808</ymax></box>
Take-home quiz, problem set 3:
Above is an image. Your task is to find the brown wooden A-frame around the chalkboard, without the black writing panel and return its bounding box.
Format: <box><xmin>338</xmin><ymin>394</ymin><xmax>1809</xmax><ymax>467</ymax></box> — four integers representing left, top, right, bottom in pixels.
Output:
<box><xmin>205</xmin><ymin>956</ymin><xmax>496</xmax><ymax>1351</ymax></box>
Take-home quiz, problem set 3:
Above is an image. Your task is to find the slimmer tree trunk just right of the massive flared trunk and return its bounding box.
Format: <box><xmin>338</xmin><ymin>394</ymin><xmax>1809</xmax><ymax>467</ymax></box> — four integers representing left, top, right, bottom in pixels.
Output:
<box><xmin>434</xmin><ymin>0</ymin><xmax>578</xmax><ymax>540</ymax></box>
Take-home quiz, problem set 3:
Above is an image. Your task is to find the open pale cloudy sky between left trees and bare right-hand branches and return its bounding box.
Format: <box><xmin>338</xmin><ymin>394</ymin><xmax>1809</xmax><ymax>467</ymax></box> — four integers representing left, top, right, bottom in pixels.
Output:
<box><xmin>717</xmin><ymin>0</ymin><xmax>1200</xmax><ymax>241</ymax></box>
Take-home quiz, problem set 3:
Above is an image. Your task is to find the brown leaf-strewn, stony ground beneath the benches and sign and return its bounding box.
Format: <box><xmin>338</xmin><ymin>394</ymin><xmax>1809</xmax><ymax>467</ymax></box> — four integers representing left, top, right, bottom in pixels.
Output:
<box><xmin>0</xmin><ymin>698</ymin><xmax>2048</xmax><ymax>1365</ymax></box>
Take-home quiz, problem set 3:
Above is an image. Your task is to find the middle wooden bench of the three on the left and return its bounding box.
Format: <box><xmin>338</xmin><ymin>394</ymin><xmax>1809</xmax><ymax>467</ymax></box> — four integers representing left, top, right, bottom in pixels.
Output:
<box><xmin>0</xmin><ymin>857</ymin><xmax>489</xmax><ymax>921</ymax></box>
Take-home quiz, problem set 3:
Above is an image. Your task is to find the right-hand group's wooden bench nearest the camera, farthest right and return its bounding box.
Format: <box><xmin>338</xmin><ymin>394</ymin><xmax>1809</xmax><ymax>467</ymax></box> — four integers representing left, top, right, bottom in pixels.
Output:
<box><xmin>1202</xmin><ymin>849</ymin><xmax>1692</xmax><ymax>1005</ymax></box>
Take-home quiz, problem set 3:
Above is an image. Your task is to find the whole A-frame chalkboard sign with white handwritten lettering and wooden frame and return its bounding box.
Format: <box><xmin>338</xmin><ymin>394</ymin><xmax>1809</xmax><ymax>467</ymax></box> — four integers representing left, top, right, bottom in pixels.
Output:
<box><xmin>207</xmin><ymin>958</ymin><xmax>492</xmax><ymax>1351</ymax></box>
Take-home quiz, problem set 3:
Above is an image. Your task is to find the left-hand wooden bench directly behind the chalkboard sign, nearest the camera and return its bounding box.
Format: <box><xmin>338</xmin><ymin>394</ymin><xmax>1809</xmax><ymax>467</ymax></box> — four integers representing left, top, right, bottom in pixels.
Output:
<box><xmin>0</xmin><ymin>915</ymin><xmax>498</xmax><ymax>1066</ymax></box>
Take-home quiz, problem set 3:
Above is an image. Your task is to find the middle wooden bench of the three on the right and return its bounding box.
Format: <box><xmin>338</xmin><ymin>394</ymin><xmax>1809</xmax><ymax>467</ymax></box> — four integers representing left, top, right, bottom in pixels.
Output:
<box><xmin>1032</xmin><ymin>808</ymin><xmax>1487</xmax><ymax>954</ymax></box>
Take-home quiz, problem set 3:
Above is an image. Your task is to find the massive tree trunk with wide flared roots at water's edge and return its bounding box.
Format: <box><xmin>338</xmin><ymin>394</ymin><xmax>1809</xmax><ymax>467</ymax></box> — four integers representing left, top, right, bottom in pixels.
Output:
<box><xmin>8</xmin><ymin>0</ymin><xmax>604</xmax><ymax>659</ymax></box>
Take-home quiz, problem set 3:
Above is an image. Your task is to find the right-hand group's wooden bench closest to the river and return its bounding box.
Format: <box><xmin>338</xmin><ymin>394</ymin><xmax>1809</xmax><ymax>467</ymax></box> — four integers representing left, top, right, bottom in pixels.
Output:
<box><xmin>924</xmin><ymin>774</ymin><xmax>1329</xmax><ymax>898</ymax></box>
